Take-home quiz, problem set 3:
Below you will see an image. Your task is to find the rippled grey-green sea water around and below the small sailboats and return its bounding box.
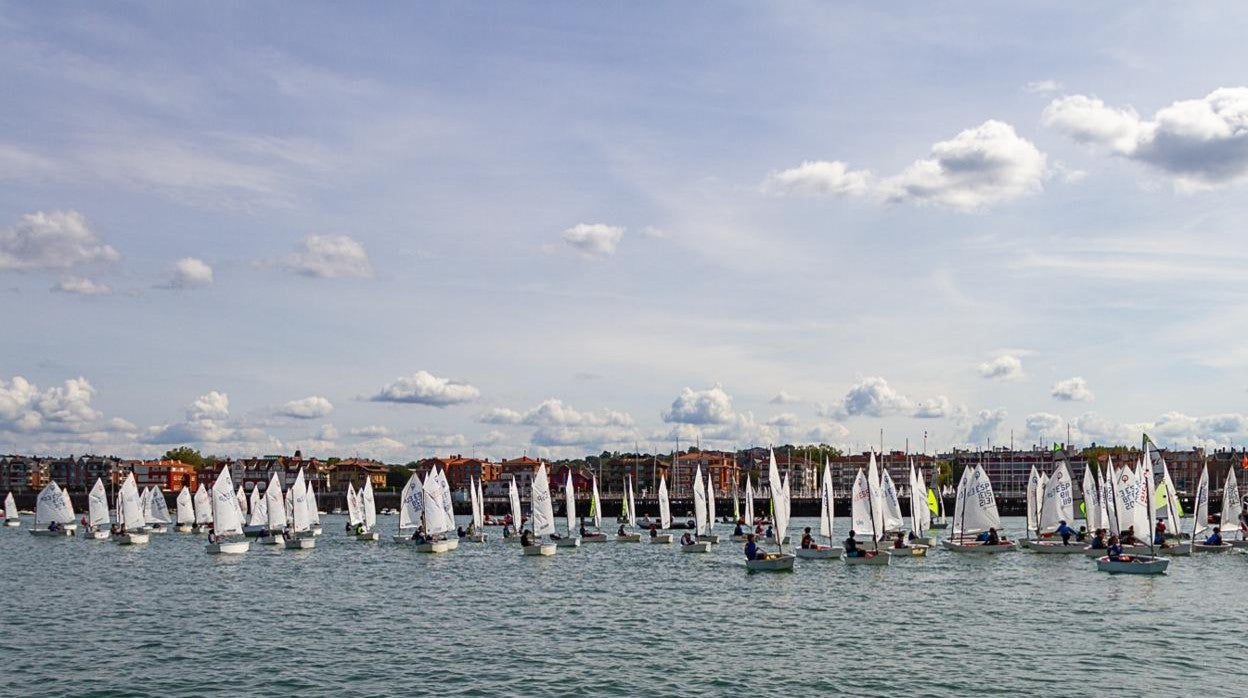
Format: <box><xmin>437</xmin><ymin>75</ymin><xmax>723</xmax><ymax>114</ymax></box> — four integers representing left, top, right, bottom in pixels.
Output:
<box><xmin>0</xmin><ymin>516</ymin><xmax>1248</xmax><ymax>697</ymax></box>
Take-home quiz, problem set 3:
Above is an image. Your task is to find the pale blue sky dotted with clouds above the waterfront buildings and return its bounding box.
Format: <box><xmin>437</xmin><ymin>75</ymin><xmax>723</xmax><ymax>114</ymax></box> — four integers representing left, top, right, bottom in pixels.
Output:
<box><xmin>0</xmin><ymin>1</ymin><xmax>1248</xmax><ymax>462</ymax></box>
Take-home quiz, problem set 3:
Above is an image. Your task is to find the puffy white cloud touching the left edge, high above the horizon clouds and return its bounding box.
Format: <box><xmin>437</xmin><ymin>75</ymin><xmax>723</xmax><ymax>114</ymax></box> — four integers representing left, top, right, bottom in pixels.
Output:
<box><xmin>0</xmin><ymin>211</ymin><xmax>121</xmax><ymax>271</ymax></box>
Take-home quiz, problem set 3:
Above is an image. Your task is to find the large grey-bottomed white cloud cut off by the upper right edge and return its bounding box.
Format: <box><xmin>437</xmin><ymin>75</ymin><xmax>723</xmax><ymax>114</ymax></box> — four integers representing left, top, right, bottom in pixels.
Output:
<box><xmin>1043</xmin><ymin>87</ymin><xmax>1248</xmax><ymax>189</ymax></box>
